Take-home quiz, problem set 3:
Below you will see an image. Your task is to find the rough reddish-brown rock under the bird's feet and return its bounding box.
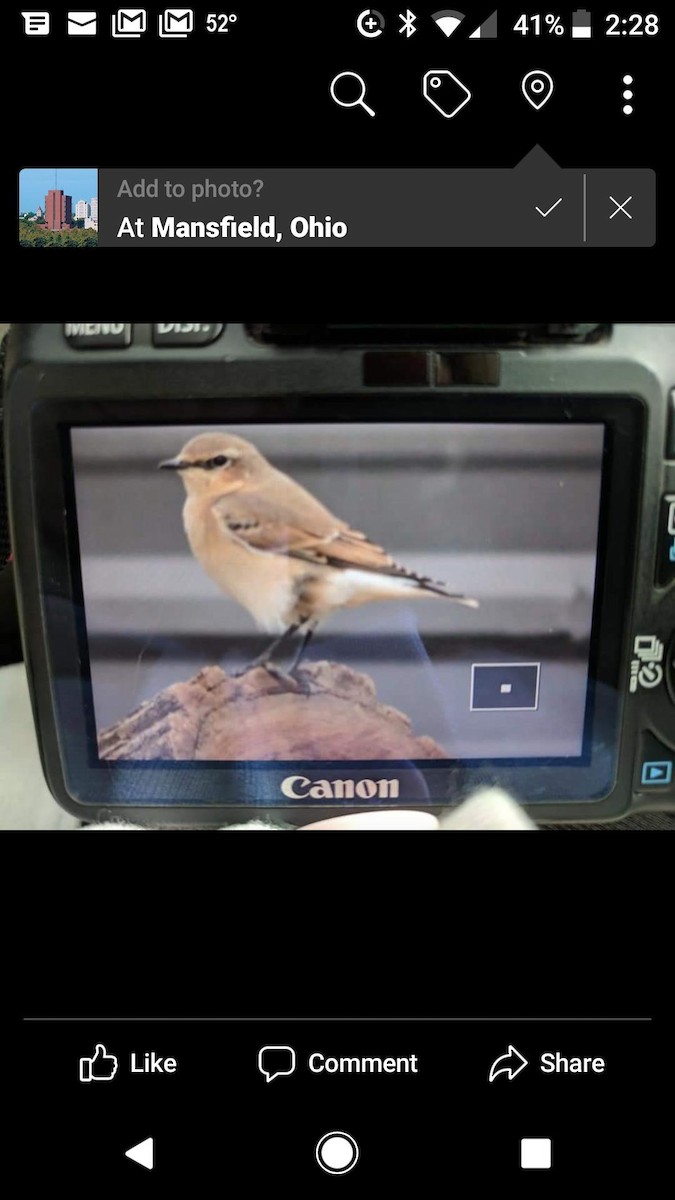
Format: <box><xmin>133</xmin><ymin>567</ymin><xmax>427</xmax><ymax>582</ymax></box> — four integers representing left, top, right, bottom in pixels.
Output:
<box><xmin>98</xmin><ymin>661</ymin><xmax>448</xmax><ymax>762</ymax></box>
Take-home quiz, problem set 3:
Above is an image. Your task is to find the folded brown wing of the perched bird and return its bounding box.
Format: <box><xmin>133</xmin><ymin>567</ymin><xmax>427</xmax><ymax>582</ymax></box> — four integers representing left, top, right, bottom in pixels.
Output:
<box><xmin>213</xmin><ymin>488</ymin><xmax>398</xmax><ymax>575</ymax></box>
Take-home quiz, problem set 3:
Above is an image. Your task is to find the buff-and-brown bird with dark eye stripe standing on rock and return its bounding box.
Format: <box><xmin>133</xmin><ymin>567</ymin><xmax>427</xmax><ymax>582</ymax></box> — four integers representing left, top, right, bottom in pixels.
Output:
<box><xmin>159</xmin><ymin>431</ymin><xmax>478</xmax><ymax>677</ymax></box>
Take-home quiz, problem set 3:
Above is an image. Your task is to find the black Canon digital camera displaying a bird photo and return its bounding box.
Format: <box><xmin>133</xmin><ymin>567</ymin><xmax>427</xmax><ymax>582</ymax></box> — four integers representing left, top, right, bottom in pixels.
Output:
<box><xmin>5</xmin><ymin>324</ymin><xmax>675</xmax><ymax>826</ymax></box>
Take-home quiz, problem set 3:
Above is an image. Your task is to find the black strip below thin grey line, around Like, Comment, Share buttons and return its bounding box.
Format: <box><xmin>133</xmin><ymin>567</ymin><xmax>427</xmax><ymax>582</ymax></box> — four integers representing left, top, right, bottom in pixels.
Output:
<box><xmin>22</xmin><ymin>1020</ymin><xmax>665</xmax><ymax>1195</ymax></box>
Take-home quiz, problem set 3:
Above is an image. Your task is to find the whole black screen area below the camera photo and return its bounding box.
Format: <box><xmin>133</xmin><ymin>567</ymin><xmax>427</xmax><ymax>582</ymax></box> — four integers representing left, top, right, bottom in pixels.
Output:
<box><xmin>4</xmin><ymin>833</ymin><xmax>673</xmax><ymax>1195</ymax></box>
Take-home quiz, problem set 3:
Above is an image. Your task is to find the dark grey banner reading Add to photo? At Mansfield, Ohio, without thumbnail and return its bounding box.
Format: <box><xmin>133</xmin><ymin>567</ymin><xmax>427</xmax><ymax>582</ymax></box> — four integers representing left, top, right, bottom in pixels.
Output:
<box><xmin>98</xmin><ymin>146</ymin><xmax>656</xmax><ymax>247</ymax></box>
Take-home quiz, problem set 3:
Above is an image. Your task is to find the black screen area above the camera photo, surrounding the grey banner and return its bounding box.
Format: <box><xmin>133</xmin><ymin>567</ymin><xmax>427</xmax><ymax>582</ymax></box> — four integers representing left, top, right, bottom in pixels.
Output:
<box><xmin>6</xmin><ymin>2</ymin><xmax>673</xmax><ymax>322</ymax></box>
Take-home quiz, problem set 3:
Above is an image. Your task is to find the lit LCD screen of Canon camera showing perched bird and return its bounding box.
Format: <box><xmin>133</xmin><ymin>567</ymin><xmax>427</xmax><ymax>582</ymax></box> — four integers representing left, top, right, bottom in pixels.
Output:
<box><xmin>70</xmin><ymin>422</ymin><xmax>605</xmax><ymax>768</ymax></box>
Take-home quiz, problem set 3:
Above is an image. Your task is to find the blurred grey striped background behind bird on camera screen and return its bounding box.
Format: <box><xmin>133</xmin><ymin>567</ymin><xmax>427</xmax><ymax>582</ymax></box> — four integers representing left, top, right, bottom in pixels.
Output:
<box><xmin>72</xmin><ymin>424</ymin><xmax>603</xmax><ymax>757</ymax></box>
